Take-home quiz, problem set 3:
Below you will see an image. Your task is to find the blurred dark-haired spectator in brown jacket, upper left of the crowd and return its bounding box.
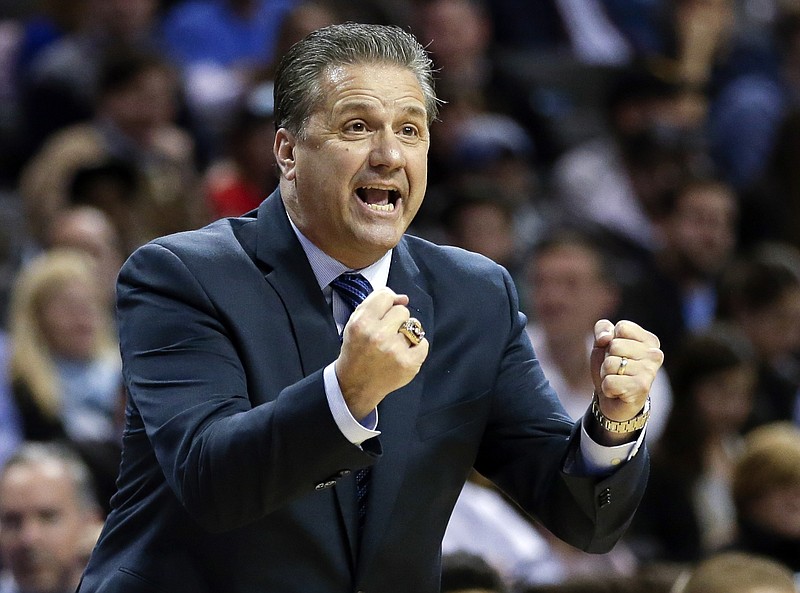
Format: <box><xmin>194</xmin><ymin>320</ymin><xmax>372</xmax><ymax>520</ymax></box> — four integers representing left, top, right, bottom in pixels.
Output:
<box><xmin>20</xmin><ymin>51</ymin><xmax>208</xmax><ymax>252</ymax></box>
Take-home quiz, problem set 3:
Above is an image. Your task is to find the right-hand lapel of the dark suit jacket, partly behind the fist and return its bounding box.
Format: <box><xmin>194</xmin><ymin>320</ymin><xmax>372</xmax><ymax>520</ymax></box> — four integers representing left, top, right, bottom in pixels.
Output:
<box><xmin>356</xmin><ymin>240</ymin><xmax>435</xmax><ymax>572</ymax></box>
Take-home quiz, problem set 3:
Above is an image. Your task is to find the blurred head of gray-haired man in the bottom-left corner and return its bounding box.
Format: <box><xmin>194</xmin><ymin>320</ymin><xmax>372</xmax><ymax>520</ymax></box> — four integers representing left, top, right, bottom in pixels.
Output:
<box><xmin>0</xmin><ymin>443</ymin><xmax>101</xmax><ymax>593</ymax></box>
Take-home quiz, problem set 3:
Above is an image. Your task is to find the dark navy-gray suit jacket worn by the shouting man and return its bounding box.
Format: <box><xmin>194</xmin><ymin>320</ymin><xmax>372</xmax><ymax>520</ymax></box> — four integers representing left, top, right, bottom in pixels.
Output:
<box><xmin>79</xmin><ymin>192</ymin><xmax>647</xmax><ymax>593</ymax></box>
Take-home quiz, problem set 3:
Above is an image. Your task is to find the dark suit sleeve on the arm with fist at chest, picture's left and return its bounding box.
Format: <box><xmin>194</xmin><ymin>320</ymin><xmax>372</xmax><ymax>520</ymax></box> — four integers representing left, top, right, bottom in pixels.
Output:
<box><xmin>117</xmin><ymin>243</ymin><xmax>374</xmax><ymax>531</ymax></box>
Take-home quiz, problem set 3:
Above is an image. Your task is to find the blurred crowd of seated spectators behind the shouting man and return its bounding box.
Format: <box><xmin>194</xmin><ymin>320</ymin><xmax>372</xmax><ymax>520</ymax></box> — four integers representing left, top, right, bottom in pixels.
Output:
<box><xmin>0</xmin><ymin>0</ymin><xmax>800</xmax><ymax>593</ymax></box>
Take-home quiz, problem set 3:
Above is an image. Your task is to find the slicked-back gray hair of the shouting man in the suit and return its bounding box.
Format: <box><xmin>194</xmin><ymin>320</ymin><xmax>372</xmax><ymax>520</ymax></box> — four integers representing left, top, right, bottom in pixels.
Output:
<box><xmin>274</xmin><ymin>23</ymin><xmax>438</xmax><ymax>136</ymax></box>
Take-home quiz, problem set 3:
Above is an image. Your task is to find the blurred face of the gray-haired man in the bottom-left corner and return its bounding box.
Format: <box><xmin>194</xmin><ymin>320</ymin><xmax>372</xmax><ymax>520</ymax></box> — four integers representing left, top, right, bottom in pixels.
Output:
<box><xmin>0</xmin><ymin>462</ymin><xmax>88</xmax><ymax>593</ymax></box>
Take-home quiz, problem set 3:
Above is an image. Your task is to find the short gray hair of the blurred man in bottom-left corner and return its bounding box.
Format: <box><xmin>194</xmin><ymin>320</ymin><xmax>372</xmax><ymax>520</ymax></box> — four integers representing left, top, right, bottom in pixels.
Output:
<box><xmin>0</xmin><ymin>441</ymin><xmax>99</xmax><ymax>510</ymax></box>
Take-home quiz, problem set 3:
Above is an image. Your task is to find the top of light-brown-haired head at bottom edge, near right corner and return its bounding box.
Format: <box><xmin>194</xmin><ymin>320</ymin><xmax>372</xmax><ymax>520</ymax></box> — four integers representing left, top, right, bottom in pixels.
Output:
<box><xmin>676</xmin><ymin>552</ymin><xmax>797</xmax><ymax>593</ymax></box>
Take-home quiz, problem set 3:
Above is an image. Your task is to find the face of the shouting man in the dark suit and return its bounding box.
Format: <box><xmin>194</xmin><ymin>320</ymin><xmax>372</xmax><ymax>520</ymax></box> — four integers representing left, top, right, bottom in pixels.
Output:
<box><xmin>275</xmin><ymin>64</ymin><xmax>429</xmax><ymax>268</ymax></box>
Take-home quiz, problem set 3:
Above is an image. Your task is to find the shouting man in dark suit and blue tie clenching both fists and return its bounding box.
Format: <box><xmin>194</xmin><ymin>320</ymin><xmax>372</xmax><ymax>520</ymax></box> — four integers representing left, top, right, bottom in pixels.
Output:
<box><xmin>79</xmin><ymin>24</ymin><xmax>662</xmax><ymax>593</ymax></box>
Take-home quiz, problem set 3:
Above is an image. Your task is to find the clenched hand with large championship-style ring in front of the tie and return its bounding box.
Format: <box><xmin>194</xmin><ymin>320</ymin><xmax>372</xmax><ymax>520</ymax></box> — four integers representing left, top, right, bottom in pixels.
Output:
<box><xmin>334</xmin><ymin>288</ymin><xmax>429</xmax><ymax>421</ymax></box>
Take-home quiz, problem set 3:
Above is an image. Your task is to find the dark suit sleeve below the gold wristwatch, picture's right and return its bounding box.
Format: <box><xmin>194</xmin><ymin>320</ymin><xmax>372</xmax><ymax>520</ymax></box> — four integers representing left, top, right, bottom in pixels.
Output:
<box><xmin>476</xmin><ymin>266</ymin><xmax>648</xmax><ymax>553</ymax></box>
